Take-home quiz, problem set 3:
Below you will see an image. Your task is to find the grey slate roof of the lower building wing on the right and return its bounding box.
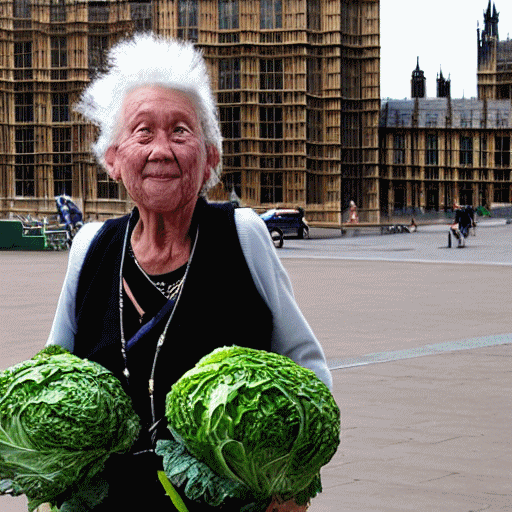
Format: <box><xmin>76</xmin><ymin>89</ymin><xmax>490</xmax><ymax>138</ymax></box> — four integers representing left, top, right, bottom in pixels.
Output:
<box><xmin>380</xmin><ymin>98</ymin><xmax>512</xmax><ymax>128</ymax></box>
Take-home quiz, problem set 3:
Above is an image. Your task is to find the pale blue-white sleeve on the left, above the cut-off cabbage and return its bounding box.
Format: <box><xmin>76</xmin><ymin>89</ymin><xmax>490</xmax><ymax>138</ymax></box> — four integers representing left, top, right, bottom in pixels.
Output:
<box><xmin>46</xmin><ymin>222</ymin><xmax>103</xmax><ymax>352</ymax></box>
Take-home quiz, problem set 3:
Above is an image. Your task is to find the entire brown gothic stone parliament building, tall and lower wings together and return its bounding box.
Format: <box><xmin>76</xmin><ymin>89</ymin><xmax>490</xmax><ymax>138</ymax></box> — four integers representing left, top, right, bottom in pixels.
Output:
<box><xmin>0</xmin><ymin>0</ymin><xmax>512</xmax><ymax>226</ymax></box>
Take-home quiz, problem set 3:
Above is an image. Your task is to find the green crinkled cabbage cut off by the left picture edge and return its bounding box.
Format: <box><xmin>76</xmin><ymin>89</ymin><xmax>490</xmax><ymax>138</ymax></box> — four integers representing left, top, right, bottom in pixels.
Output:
<box><xmin>0</xmin><ymin>346</ymin><xmax>140</xmax><ymax>510</ymax></box>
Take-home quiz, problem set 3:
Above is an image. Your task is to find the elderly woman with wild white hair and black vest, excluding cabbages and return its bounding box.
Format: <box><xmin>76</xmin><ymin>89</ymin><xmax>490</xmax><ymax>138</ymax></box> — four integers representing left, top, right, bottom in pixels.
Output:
<box><xmin>48</xmin><ymin>35</ymin><xmax>331</xmax><ymax>512</ymax></box>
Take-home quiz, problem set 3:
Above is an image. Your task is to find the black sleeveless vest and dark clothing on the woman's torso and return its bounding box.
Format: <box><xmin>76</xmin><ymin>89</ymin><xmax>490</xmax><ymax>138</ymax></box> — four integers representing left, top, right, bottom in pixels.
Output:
<box><xmin>74</xmin><ymin>200</ymin><xmax>272</xmax><ymax>512</ymax></box>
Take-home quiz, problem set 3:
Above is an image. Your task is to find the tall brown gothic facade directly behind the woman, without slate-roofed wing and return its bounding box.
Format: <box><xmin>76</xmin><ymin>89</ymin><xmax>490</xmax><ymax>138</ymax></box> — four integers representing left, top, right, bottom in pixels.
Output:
<box><xmin>0</xmin><ymin>0</ymin><xmax>380</xmax><ymax>224</ymax></box>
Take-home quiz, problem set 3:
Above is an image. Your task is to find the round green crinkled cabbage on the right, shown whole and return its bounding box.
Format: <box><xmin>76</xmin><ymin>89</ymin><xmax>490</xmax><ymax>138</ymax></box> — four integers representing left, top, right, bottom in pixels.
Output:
<box><xmin>166</xmin><ymin>346</ymin><xmax>340</xmax><ymax>498</ymax></box>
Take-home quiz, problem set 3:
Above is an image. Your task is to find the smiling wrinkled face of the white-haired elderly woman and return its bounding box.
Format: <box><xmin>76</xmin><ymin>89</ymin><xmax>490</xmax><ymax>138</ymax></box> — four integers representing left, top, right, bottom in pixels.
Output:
<box><xmin>105</xmin><ymin>86</ymin><xmax>214</xmax><ymax>213</ymax></box>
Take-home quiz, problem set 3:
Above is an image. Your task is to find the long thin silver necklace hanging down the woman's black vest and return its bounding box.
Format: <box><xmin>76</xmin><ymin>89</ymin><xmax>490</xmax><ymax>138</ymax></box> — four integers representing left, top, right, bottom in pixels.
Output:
<box><xmin>119</xmin><ymin>215</ymin><xmax>199</xmax><ymax>426</ymax></box>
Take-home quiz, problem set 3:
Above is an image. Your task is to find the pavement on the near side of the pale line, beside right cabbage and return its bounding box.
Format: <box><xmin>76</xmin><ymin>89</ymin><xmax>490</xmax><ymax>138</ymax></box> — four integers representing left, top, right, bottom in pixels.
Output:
<box><xmin>310</xmin><ymin>345</ymin><xmax>512</xmax><ymax>512</ymax></box>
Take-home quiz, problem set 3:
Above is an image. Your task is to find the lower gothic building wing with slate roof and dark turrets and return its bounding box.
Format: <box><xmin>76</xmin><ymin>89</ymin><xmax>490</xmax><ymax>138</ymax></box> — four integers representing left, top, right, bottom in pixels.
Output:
<box><xmin>379</xmin><ymin>2</ymin><xmax>512</xmax><ymax>215</ymax></box>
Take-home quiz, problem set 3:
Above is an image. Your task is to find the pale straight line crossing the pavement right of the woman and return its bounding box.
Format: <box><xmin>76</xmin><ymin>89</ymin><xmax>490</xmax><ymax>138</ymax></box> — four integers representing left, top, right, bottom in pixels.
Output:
<box><xmin>327</xmin><ymin>333</ymin><xmax>512</xmax><ymax>371</ymax></box>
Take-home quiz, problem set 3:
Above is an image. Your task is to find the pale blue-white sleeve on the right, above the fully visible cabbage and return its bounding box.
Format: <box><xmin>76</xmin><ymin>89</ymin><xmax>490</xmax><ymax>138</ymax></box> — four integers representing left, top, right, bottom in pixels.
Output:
<box><xmin>235</xmin><ymin>208</ymin><xmax>332</xmax><ymax>389</ymax></box>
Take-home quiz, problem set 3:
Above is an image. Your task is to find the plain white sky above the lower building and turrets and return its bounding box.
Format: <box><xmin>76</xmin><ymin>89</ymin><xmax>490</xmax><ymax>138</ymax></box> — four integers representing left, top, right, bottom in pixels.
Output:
<box><xmin>380</xmin><ymin>0</ymin><xmax>512</xmax><ymax>99</ymax></box>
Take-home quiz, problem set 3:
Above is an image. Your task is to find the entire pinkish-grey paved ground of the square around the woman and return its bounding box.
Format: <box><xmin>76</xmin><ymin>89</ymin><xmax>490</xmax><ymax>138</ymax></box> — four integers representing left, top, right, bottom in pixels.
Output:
<box><xmin>0</xmin><ymin>225</ymin><xmax>512</xmax><ymax>512</ymax></box>
